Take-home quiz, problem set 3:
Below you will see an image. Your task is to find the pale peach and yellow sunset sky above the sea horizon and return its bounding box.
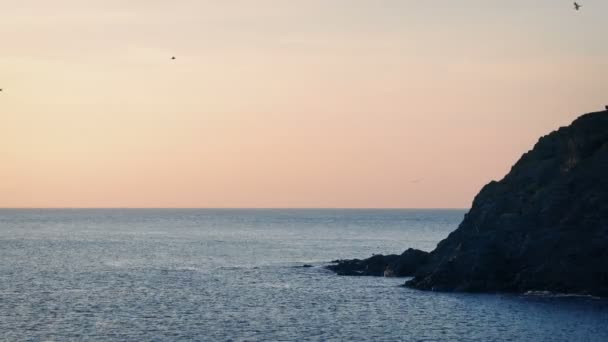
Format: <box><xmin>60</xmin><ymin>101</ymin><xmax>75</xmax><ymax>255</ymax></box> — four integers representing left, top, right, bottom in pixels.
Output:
<box><xmin>0</xmin><ymin>0</ymin><xmax>608</xmax><ymax>208</ymax></box>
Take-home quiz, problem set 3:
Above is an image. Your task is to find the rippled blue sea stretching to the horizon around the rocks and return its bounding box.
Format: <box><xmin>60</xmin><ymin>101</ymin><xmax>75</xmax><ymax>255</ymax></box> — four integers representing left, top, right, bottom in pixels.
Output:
<box><xmin>0</xmin><ymin>210</ymin><xmax>608</xmax><ymax>341</ymax></box>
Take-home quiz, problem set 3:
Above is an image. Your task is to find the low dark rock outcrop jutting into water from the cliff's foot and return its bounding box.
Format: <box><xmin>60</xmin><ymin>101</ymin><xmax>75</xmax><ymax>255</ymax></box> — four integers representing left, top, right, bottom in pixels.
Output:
<box><xmin>327</xmin><ymin>248</ymin><xmax>429</xmax><ymax>277</ymax></box>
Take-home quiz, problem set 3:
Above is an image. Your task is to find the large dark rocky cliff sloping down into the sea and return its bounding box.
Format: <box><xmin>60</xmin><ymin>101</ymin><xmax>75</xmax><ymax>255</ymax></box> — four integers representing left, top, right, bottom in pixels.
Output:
<box><xmin>406</xmin><ymin>111</ymin><xmax>608</xmax><ymax>296</ymax></box>
